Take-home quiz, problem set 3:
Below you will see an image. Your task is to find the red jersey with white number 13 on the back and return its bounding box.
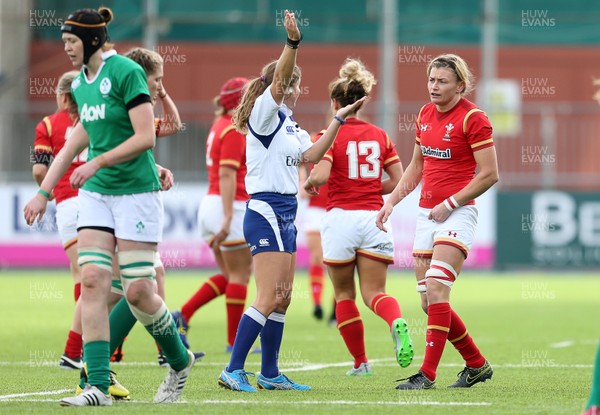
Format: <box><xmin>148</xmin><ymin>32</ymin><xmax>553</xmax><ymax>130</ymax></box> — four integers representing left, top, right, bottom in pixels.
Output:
<box><xmin>323</xmin><ymin>118</ymin><xmax>400</xmax><ymax>210</ymax></box>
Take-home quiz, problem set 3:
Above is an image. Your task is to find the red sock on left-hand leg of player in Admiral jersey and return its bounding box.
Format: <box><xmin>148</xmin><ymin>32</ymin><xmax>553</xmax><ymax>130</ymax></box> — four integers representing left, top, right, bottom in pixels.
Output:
<box><xmin>421</xmin><ymin>303</ymin><xmax>452</xmax><ymax>380</ymax></box>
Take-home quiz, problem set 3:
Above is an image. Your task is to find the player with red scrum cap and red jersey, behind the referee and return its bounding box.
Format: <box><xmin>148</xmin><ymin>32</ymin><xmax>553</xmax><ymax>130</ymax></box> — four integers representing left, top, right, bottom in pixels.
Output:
<box><xmin>173</xmin><ymin>77</ymin><xmax>253</xmax><ymax>352</ymax></box>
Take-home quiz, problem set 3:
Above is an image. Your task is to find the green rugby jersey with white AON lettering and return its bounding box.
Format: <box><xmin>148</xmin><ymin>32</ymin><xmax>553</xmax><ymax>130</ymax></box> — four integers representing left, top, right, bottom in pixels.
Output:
<box><xmin>71</xmin><ymin>50</ymin><xmax>161</xmax><ymax>195</ymax></box>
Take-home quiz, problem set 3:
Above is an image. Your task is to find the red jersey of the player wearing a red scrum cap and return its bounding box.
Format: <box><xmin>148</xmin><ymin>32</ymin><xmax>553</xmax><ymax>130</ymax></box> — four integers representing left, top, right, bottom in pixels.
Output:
<box><xmin>206</xmin><ymin>114</ymin><xmax>249</xmax><ymax>200</ymax></box>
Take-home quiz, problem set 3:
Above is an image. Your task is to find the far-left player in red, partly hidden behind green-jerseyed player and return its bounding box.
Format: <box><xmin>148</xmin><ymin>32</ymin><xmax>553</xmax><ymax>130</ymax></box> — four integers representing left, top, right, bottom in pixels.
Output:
<box><xmin>33</xmin><ymin>71</ymin><xmax>87</xmax><ymax>369</ymax></box>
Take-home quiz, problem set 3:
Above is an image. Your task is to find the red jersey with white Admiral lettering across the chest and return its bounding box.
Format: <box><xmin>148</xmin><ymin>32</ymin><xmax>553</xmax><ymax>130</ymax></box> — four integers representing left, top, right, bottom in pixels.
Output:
<box><xmin>416</xmin><ymin>98</ymin><xmax>494</xmax><ymax>209</ymax></box>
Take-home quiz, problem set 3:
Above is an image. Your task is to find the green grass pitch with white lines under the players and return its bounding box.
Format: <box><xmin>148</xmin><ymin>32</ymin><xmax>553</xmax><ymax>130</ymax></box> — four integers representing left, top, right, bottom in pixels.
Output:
<box><xmin>0</xmin><ymin>271</ymin><xmax>600</xmax><ymax>415</ymax></box>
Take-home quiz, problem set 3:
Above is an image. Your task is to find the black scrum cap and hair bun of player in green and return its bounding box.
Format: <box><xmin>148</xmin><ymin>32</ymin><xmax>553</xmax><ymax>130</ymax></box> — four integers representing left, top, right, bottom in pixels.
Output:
<box><xmin>60</xmin><ymin>7</ymin><xmax>113</xmax><ymax>64</ymax></box>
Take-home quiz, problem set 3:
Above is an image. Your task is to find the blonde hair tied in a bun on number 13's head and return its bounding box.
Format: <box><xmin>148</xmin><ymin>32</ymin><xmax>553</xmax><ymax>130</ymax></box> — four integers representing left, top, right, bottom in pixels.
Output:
<box><xmin>329</xmin><ymin>58</ymin><xmax>377</xmax><ymax>107</ymax></box>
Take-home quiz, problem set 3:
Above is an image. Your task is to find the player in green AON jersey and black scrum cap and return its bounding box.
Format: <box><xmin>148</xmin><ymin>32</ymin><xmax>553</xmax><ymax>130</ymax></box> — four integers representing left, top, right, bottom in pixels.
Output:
<box><xmin>25</xmin><ymin>8</ymin><xmax>194</xmax><ymax>406</ymax></box>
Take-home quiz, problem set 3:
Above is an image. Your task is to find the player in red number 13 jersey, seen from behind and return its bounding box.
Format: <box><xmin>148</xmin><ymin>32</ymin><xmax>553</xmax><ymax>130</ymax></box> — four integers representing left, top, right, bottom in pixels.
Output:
<box><xmin>304</xmin><ymin>59</ymin><xmax>413</xmax><ymax>376</ymax></box>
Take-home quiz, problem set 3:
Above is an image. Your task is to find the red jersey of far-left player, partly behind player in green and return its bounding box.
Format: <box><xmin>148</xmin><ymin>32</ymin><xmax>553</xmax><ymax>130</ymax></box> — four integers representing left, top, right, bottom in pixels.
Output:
<box><xmin>33</xmin><ymin>110</ymin><xmax>87</xmax><ymax>204</ymax></box>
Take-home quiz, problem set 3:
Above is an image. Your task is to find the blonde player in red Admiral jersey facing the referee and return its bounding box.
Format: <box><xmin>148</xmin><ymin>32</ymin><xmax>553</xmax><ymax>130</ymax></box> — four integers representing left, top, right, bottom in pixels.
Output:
<box><xmin>377</xmin><ymin>54</ymin><xmax>498</xmax><ymax>389</ymax></box>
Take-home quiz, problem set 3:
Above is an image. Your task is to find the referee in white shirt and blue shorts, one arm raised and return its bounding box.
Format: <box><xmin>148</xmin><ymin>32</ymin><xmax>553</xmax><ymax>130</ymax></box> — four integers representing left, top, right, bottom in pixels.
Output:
<box><xmin>219</xmin><ymin>10</ymin><xmax>364</xmax><ymax>392</ymax></box>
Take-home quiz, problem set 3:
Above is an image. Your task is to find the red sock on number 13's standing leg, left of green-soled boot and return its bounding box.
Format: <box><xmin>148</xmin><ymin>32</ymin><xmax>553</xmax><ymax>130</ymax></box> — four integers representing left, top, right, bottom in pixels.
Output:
<box><xmin>335</xmin><ymin>300</ymin><xmax>368</xmax><ymax>368</ymax></box>
